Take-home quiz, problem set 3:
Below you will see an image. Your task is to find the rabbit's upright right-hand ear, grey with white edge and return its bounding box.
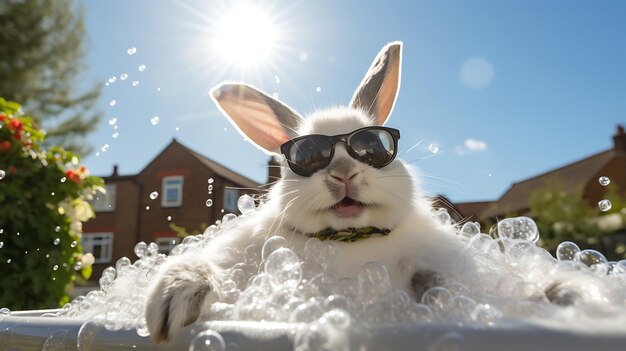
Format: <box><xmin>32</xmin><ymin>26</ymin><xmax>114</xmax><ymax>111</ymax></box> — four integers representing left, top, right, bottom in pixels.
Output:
<box><xmin>350</xmin><ymin>41</ymin><xmax>402</xmax><ymax>125</ymax></box>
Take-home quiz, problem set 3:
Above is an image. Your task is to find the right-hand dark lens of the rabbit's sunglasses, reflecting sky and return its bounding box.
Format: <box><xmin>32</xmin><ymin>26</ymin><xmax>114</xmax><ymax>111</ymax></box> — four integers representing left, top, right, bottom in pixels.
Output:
<box><xmin>348</xmin><ymin>129</ymin><xmax>395</xmax><ymax>167</ymax></box>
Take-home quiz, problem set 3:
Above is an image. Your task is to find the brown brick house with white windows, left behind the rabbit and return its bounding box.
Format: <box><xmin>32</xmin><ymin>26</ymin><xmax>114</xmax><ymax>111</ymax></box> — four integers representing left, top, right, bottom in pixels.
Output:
<box><xmin>82</xmin><ymin>139</ymin><xmax>262</xmax><ymax>279</ymax></box>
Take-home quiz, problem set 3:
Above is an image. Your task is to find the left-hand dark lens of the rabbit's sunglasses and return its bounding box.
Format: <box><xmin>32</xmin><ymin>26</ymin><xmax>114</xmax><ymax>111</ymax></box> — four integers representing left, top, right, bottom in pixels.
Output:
<box><xmin>289</xmin><ymin>135</ymin><xmax>332</xmax><ymax>175</ymax></box>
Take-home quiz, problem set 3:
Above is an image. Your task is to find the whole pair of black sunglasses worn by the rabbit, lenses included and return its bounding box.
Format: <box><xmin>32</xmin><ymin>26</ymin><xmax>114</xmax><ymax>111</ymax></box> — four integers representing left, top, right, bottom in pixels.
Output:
<box><xmin>280</xmin><ymin>126</ymin><xmax>400</xmax><ymax>177</ymax></box>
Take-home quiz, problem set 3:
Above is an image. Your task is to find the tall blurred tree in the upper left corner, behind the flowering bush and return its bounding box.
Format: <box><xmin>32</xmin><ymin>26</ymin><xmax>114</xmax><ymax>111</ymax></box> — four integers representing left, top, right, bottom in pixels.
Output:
<box><xmin>0</xmin><ymin>0</ymin><xmax>100</xmax><ymax>155</ymax></box>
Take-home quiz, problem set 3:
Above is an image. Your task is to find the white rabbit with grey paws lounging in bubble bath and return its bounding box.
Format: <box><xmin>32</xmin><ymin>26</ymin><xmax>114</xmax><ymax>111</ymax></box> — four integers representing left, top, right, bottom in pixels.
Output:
<box><xmin>146</xmin><ymin>42</ymin><xmax>472</xmax><ymax>342</ymax></box>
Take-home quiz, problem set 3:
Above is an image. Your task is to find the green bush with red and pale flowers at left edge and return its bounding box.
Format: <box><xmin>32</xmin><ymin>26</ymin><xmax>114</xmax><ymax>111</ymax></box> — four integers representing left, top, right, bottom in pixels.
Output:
<box><xmin>0</xmin><ymin>98</ymin><xmax>104</xmax><ymax>309</ymax></box>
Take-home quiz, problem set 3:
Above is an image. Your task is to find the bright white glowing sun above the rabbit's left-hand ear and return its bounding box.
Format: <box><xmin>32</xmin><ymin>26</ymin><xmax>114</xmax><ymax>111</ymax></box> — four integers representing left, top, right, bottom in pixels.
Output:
<box><xmin>213</xmin><ymin>4</ymin><xmax>278</xmax><ymax>68</ymax></box>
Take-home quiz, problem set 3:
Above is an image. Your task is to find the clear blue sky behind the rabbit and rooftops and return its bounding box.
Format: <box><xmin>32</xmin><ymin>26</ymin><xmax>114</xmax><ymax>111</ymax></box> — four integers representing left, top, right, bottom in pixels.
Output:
<box><xmin>82</xmin><ymin>0</ymin><xmax>626</xmax><ymax>202</ymax></box>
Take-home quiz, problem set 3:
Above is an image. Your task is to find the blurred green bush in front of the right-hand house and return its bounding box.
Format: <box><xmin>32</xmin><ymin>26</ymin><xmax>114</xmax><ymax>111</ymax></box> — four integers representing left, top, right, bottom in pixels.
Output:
<box><xmin>530</xmin><ymin>184</ymin><xmax>603</xmax><ymax>249</ymax></box>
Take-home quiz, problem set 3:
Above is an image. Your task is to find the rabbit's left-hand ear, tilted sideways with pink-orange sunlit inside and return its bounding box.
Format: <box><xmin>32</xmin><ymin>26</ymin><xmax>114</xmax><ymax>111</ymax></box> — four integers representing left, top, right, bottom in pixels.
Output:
<box><xmin>211</xmin><ymin>84</ymin><xmax>302</xmax><ymax>154</ymax></box>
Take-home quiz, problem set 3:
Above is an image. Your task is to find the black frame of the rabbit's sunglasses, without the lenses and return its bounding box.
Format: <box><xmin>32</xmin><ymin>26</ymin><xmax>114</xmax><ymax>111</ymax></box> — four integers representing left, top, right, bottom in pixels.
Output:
<box><xmin>280</xmin><ymin>126</ymin><xmax>400</xmax><ymax>177</ymax></box>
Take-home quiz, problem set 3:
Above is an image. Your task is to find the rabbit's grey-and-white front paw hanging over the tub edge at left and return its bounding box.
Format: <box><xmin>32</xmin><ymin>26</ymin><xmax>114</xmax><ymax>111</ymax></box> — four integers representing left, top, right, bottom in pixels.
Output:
<box><xmin>146</xmin><ymin>257</ymin><xmax>219</xmax><ymax>343</ymax></box>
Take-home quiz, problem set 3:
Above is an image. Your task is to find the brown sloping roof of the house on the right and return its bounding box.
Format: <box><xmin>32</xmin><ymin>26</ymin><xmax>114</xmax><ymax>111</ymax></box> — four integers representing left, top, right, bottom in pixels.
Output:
<box><xmin>479</xmin><ymin>149</ymin><xmax>617</xmax><ymax>219</ymax></box>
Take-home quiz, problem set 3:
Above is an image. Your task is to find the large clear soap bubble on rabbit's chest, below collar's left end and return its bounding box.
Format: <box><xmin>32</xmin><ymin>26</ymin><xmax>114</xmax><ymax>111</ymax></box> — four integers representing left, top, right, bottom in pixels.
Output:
<box><xmin>264</xmin><ymin>247</ymin><xmax>302</xmax><ymax>287</ymax></box>
